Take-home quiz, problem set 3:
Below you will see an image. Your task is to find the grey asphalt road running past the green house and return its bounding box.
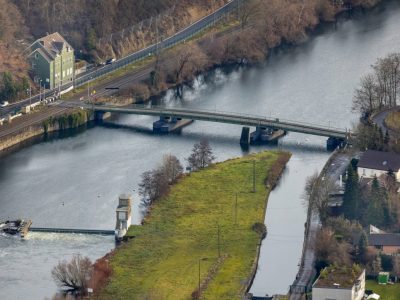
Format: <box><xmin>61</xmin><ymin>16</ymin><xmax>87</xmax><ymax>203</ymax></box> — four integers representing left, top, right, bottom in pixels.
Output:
<box><xmin>0</xmin><ymin>0</ymin><xmax>240</xmax><ymax>118</ymax></box>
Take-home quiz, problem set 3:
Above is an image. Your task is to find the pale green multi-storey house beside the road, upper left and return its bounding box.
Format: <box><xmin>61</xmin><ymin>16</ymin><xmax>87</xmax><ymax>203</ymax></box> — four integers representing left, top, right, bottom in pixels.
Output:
<box><xmin>28</xmin><ymin>32</ymin><xmax>75</xmax><ymax>89</ymax></box>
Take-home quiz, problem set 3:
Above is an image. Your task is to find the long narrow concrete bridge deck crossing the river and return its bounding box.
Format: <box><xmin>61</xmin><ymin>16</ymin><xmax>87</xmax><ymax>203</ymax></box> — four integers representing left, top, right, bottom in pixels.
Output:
<box><xmin>60</xmin><ymin>102</ymin><xmax>351</xmax><ymax>146</ymax></box>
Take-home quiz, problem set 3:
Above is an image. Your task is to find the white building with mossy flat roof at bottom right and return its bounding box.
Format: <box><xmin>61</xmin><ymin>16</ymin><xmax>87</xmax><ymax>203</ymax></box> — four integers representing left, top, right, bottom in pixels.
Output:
<box><xmin>312</xmin><ymin>265</ymin><xmax>365</xmax><ymax>300</ymax></box>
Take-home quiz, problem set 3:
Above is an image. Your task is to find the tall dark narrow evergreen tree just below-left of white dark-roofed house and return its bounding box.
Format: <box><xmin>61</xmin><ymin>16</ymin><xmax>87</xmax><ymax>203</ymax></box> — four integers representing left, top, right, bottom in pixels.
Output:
<box><xmin>343</xmin><ymin>165</ymin><xmax>361</xmax><ymax>220</ymax></box>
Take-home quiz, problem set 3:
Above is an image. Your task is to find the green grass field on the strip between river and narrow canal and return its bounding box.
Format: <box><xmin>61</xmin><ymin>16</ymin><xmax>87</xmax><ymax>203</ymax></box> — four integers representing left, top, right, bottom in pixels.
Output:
<box><xmin>99</xmin><ymin>152</ymin><xmax>290</xmax><ymax>300</ymax></box>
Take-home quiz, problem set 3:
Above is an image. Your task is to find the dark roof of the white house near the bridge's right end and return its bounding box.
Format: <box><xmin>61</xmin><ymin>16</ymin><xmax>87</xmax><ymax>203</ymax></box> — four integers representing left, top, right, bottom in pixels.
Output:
<box><xmin>358</xmin><ymin>150</ymin><xmax>400</xmax><ymax>172</ymax></box>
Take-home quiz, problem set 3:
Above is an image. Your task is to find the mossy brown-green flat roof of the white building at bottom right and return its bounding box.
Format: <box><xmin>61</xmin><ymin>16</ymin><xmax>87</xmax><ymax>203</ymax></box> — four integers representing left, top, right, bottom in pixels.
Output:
<box><xmin>313</xmin><ymin>265</ymin><xmax>364</xmax><ymax>289</ymax></box>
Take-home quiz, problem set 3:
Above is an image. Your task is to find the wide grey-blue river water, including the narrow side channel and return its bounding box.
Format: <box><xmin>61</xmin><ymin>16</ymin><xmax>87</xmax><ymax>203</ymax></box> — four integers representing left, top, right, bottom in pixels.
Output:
<box><xmin>0</xmin><ymin>1</ymin><xmax>400</xmax><ymax>300</ymax></box>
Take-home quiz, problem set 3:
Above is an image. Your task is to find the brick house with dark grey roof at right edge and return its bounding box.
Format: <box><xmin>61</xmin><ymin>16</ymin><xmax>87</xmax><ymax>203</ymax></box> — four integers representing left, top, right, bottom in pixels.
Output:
<box><xmin>368</xmin><ymin>225</ymin><xmax>400</xmax><ymax>255</ymax></box>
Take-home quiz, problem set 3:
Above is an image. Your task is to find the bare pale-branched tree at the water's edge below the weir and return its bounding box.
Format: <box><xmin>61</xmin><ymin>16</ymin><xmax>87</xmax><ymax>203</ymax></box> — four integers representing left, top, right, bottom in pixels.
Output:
<box><xmin>51</xmin><ymin>254</ymin><xmax>93</xmax><ymax>294</ymax></box>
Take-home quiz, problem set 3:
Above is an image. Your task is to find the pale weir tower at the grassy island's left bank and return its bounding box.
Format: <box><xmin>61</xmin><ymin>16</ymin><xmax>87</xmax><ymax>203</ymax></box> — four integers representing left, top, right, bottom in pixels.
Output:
<box><xmin>115</xmin><ymin>194</ymin><xmax>132</xmax><ymax>241</ymax></box>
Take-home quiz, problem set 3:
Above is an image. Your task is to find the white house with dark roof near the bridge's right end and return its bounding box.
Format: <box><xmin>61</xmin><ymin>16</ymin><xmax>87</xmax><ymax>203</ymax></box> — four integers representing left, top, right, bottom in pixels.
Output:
<box><xmin>357</xmin><ymin>150</ymin><xmax>400</xmax><ymax>182</ymax></box>
